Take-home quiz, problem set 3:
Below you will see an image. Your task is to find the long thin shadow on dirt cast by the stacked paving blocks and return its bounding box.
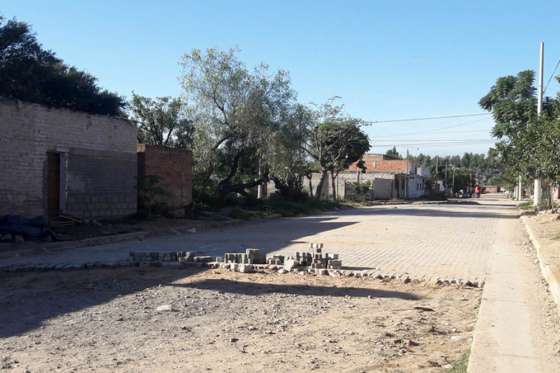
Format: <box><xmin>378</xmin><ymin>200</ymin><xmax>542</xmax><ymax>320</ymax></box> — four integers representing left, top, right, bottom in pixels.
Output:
<box><xmin>170</xmin><ymin>279</ymin><xmax>420</xmax><ymax>300</ymax></box>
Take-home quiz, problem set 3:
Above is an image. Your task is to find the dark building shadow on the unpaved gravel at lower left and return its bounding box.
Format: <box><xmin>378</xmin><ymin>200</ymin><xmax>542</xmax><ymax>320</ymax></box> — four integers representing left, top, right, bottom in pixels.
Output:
<box><xmin>0</xmin><ymin>268</ymin><xmax>206</xmax><ymax>338</ymax></box>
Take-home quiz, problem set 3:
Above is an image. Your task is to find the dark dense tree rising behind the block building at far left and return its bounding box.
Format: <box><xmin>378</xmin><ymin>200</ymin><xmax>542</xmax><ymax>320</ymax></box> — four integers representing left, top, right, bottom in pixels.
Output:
<box><xmin>0</xmin><ymin>17</ymin><xmax>125</xmax><ymax>115</ymax></box>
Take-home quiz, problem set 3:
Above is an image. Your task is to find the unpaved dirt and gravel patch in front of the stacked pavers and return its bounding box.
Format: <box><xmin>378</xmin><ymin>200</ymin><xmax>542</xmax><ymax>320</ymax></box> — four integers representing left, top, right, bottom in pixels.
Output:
<box><xmin>0</xmin><ymin>268</ymin><xmax>481</xmax><ymax>372</ymax></box>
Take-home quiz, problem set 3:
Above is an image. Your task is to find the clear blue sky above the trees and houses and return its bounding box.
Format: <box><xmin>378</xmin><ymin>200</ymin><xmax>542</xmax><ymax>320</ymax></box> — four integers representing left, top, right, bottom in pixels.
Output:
<box><xmin>4</xmin><ymin>0</ymin><xmax>560</xmax><ymax>155</ymax></box>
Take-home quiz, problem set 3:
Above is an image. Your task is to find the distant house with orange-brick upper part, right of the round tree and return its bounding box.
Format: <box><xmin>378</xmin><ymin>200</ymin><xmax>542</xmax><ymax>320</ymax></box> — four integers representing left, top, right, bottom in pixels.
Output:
<box><xmin>306</xmin><ymin>154</ymin><xmax>429</xmax><ymax>200</ymax></box>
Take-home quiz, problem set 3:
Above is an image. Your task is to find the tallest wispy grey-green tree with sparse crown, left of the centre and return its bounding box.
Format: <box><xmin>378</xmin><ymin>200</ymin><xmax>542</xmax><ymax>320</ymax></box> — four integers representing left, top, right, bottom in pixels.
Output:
<box><xmin>182</xmin><ymin>49</ymin><xmax>295</xmax><ymax>202</ymax></box>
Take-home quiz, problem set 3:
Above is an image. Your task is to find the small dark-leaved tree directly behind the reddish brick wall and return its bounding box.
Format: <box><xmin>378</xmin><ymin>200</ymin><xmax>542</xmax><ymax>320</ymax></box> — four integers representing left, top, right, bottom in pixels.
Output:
<box><xmin>130</xmin><ymin>93</ymin><xmax>193</xmax><ymax>148</ymax></box>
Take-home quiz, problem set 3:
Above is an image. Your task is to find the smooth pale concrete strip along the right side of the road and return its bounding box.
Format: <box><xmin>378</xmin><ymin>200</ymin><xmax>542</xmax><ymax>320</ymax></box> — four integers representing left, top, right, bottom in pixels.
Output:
<box><xmin>468</xmin><ymin>214</ymin><xmax>560</xmax><ymax>373</ymax></box>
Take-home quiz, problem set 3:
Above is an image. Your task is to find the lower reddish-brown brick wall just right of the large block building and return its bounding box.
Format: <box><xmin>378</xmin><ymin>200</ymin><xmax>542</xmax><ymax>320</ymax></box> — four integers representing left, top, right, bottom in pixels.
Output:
<box><xmin>138</xmin><ymin>144</ymin><xmax>192</xmax><ymax>216</ymax></box>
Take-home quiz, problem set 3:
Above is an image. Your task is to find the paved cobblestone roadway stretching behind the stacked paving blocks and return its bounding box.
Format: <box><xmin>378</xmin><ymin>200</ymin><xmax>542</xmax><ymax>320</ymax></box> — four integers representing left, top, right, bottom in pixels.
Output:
<box><xmin>0</xmin><ymin>197</ymin><xmax>517</xmax><ymax>279</ymax></box>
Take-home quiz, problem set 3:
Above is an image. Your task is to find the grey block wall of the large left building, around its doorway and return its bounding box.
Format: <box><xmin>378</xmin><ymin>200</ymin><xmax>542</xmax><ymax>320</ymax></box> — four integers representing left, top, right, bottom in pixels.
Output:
<box><xmin>0</xmin><ymin>98</ymin><xmax>137</xmax><ymax>217</ymax></box>
